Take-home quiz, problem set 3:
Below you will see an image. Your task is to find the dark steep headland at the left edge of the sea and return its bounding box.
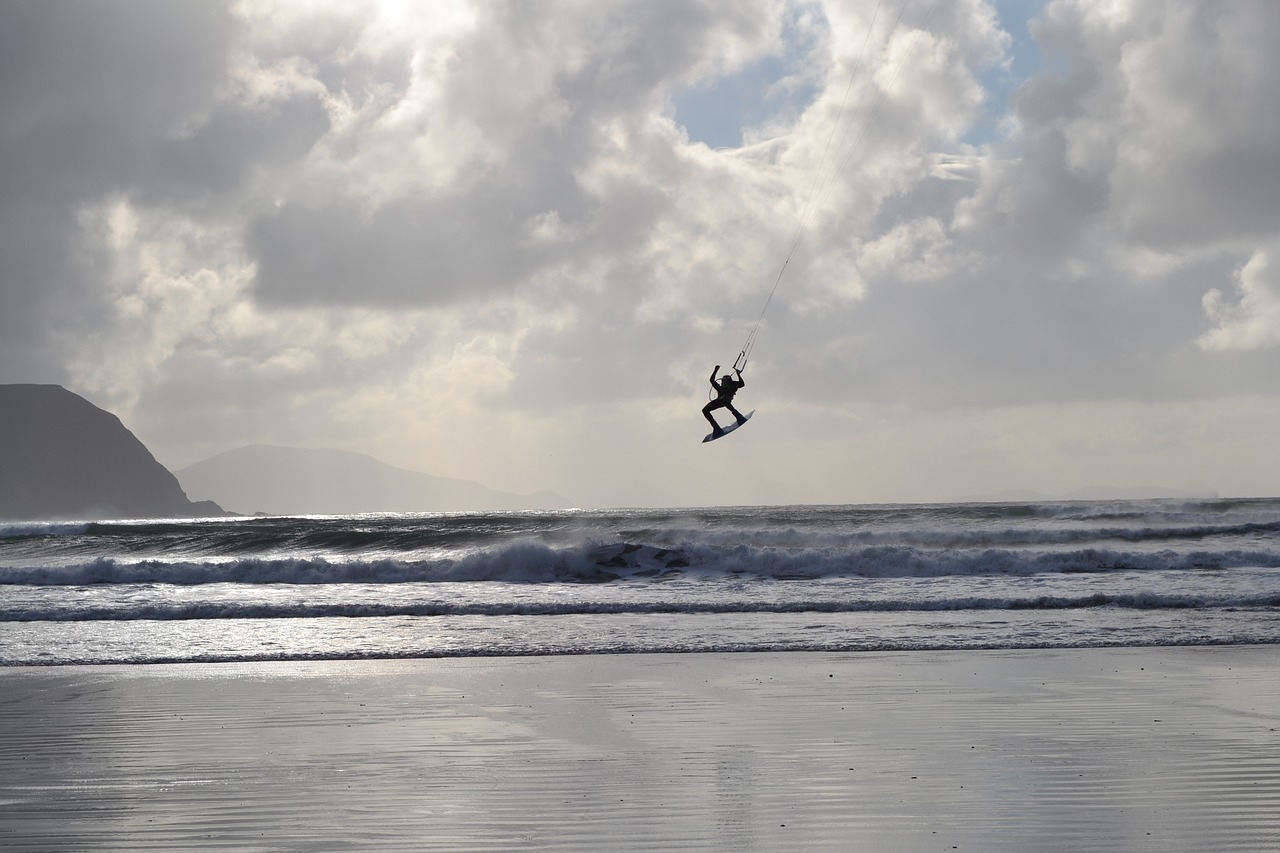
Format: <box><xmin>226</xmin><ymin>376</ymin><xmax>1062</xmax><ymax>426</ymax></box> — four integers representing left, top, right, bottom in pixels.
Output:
<box><xmin>0</xmin><ymin>384</ymin><xmax>223</xmax><ymax>520</ymax></box>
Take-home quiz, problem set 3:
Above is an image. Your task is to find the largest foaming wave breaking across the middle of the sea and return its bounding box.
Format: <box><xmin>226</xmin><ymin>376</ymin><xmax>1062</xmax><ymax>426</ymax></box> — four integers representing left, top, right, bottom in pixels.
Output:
<box><xmin>0</xmin><ymin>542</ymin><xmax>1280</xmax><ymax>587</ymax></box>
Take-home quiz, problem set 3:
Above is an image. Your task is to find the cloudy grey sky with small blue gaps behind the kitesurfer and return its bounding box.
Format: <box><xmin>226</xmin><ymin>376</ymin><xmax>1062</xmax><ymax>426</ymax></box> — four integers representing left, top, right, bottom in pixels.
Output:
<box><xmin>0</xmin><ymin>0</ymin><xmax>1280</xmax><ymax>507</ymax></box>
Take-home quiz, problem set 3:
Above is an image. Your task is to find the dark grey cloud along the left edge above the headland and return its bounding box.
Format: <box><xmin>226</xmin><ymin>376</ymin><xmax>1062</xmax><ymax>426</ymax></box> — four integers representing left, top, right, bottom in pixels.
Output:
<box><xmin>0</xmin><ymin>0</ymin><xmax>234</xmax><ymax>382</ymax></box>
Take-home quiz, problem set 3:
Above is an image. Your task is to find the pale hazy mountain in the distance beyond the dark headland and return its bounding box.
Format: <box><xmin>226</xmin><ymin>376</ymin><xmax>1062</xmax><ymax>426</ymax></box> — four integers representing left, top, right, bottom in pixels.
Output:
<box><xmin>177</xmin><ymin>444</ymin><xmax>570</xmax><ymax>515</ymax></box>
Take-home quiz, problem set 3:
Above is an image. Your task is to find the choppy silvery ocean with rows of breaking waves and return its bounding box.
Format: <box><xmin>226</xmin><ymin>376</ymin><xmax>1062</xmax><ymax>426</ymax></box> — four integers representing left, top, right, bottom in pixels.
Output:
<box><xmin>0</xmin><ymin>498</ymin><xmax>1280</xmax><ymax>666</ymax></box>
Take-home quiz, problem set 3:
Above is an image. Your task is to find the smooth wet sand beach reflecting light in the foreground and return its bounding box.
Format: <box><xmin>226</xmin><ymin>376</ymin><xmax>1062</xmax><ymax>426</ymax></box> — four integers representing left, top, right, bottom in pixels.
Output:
<box><xmin>0</xmin><ymin>646</ymin><xmax>1280</xmax><ymax>852</ymax></box>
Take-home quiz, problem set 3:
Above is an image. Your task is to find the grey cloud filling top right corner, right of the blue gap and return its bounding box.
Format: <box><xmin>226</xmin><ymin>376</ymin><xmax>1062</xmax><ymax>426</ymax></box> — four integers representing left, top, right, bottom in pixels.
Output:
<box><xmin>1015</xmin><ymin>0</ymin><xmax>1280</xmax><ymax>251</ymax></box>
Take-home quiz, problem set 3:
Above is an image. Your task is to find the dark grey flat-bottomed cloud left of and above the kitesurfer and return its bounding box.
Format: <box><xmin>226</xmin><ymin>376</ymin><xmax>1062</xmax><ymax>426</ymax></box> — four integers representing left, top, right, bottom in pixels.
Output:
<box><xmin>248</xmin><ymin>157</ymin><xmax>664</xmax><ymax>306</ymax></box>
